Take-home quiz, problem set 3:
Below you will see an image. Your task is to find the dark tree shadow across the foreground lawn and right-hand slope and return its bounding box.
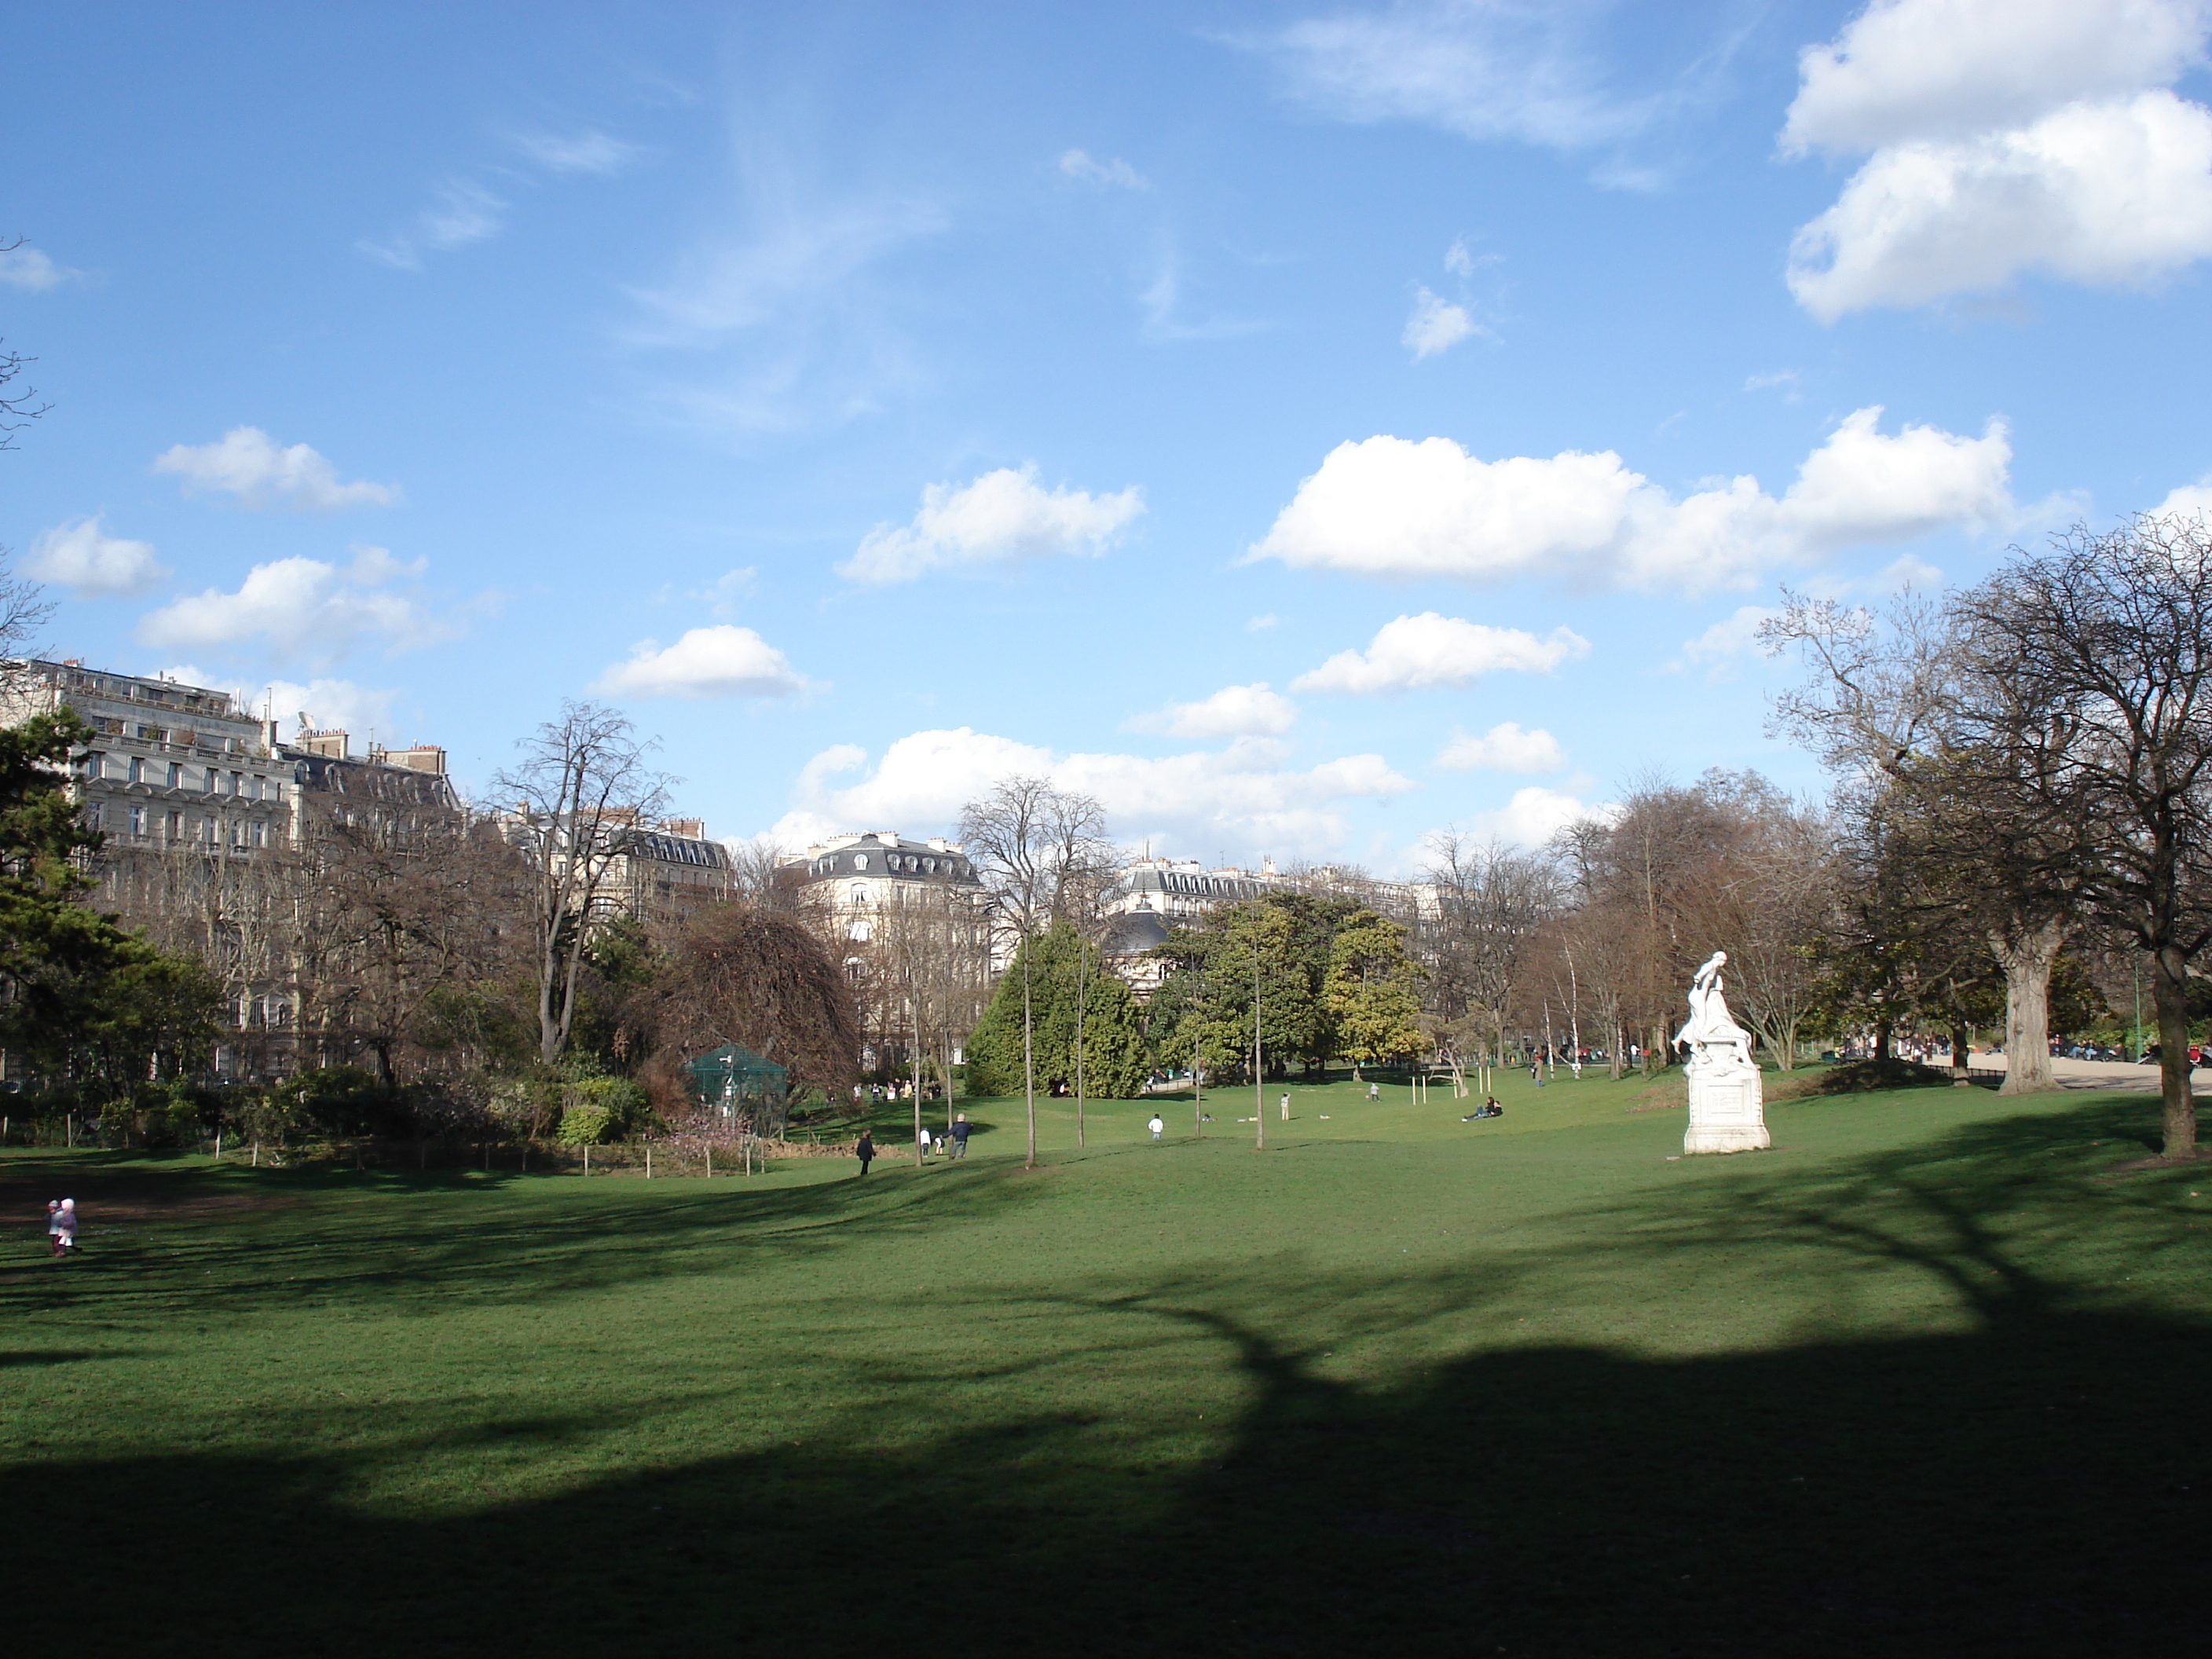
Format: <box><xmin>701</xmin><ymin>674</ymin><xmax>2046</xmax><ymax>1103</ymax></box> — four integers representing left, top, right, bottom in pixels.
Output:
<box><xmin>0</xmin><ymin>1097</ymin><xmax>2212</xmax><ymax>1659</ymax></box>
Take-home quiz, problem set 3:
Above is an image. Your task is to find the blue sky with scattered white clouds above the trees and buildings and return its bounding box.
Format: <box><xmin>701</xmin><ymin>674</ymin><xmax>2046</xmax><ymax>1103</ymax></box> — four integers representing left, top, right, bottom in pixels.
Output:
<box><xmin>13</xmin><ymin>0</ymin><xmax>2212</xmax><ymax>872</ymax></box>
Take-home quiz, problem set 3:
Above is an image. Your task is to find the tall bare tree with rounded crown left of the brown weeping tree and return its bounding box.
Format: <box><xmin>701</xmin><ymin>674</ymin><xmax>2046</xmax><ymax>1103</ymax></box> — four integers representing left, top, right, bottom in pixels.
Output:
<box><xmin>493</xmin><ymin>703</ymin><xmax>670</xmax><ymax>1066</ymax></box>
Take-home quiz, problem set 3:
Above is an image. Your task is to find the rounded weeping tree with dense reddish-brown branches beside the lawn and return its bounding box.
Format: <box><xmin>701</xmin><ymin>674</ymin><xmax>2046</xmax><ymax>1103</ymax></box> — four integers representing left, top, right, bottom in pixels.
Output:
<box><xmin>639</xmin><ymin>905</ymin><xmax>860</xmax><ymax>1135</ymax></box>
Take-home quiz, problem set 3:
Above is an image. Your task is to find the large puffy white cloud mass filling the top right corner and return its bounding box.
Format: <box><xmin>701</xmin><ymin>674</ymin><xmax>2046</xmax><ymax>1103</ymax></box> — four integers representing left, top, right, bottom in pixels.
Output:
<box><xmin>1781</xmin><ymin>0</ymin><xmax>2212</xmax><ymax>320</ymax></box>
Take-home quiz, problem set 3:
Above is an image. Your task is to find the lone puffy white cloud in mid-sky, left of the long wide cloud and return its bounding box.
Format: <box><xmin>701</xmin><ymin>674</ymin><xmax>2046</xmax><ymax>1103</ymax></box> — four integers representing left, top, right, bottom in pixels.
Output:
<box><xmin>838</xmin><ymin>467</ymin><xmax>1144</xmax><ymax>582</ymax></box>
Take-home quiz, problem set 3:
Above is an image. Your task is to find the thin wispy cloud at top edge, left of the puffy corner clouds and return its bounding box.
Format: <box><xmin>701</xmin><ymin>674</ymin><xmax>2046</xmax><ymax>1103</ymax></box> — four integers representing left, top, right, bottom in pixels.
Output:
<box><xmin>1258</xmin><ymin>5</ymin><xmax>1650</xmax><ymax>150</ymax></box>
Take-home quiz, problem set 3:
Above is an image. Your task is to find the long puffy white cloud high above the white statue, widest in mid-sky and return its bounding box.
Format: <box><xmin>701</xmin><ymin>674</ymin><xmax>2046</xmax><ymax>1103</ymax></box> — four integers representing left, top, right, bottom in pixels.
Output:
<box><xmin>1247</xmin><ymin>407</ymin><xmax>2013</xmax><ymax>593</ymax></box>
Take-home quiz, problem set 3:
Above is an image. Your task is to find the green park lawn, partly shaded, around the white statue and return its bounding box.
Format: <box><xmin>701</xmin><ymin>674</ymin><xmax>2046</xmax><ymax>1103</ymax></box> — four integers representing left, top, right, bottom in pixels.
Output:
<box><xmin>0</xmin><ymin>1073</ymin><xmax>2212</xmax><ymax>1654</ymax></box>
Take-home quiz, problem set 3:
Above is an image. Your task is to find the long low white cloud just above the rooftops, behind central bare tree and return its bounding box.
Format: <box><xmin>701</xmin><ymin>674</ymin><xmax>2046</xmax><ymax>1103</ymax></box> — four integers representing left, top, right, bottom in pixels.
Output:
<box><xmin>767</xmin><ymin>726</ymin><xmax>1418</xmax><ymax>856</ymax></box>
